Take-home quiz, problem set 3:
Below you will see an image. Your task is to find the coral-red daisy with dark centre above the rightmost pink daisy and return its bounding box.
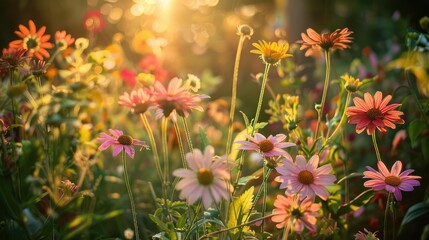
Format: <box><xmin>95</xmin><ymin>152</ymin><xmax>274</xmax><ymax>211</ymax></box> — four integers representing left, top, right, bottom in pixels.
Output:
<box><xmin>346</xmin><ymin>91</ymin><xmax>404</xmax><ymax>135</ymax></box>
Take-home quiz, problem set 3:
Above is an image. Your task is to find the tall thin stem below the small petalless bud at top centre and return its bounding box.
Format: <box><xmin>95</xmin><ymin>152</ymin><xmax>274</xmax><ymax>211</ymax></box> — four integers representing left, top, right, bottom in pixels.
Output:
<box><xmin>226</xmin><ymin>34</ymin><xmax>246</xmax><ymax>156</ymax></box>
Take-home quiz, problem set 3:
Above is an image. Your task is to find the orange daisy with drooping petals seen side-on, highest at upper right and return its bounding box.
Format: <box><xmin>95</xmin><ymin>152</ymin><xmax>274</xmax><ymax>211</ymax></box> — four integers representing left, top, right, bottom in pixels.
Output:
<box><xmin>297</xmin><ymin>28</ymin><xmax>353</xmax><ymax>56</ymax></box>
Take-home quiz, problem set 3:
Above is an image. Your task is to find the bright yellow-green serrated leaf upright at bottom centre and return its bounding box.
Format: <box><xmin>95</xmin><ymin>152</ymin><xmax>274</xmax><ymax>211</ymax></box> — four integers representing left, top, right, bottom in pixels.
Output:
<box><xmin>227</xmin><ymin>186</ymin><xmax>254</xmax><ymax>233</ymax></box>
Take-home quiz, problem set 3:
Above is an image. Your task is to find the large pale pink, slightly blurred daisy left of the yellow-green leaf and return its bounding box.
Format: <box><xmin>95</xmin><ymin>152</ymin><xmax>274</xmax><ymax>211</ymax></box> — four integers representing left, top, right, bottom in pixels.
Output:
<box><xmin>173</xmin><ymin>146</ymin><xmax>233</xmax><ymax>209</ymax></box>
